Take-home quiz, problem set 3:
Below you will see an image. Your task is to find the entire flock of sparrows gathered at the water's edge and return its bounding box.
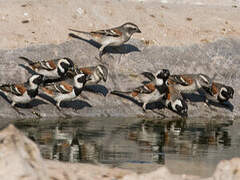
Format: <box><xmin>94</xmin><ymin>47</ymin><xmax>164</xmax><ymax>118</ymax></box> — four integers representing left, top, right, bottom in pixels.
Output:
<box><xmin>0</xmin><ymin>22</ymin><xmax>234</xmax><ymax>117</ymax></box>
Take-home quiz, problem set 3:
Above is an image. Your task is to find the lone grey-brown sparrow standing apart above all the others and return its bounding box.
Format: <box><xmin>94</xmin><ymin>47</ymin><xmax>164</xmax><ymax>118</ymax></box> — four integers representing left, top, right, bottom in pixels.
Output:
<box><xmin>69</xmin><ymin>22</ymin><xmax>141</xmax><ymax>60</ymax></box>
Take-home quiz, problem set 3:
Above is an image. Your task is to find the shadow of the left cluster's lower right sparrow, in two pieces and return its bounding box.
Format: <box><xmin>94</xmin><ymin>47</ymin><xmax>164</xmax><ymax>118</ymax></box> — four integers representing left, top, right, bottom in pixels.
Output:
<box><xmin>38</xmin><ymin>93</ymin><xmax>92</xmax><ymax>110</ymax></box>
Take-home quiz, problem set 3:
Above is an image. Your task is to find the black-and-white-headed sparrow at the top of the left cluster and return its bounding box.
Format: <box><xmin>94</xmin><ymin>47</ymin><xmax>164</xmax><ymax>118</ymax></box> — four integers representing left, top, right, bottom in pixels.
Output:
<box><xmin>19</xmin><ymin>57</ymin><xmax>74</xmax><ymax>78</ymax></box>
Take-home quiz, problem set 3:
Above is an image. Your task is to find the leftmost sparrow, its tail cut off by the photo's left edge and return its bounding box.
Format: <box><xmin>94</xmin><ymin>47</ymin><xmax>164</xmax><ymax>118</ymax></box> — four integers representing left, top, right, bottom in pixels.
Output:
<box><xmin>0</xmin><ymin>74</ymin><xmax>44</xmax><ymax>113</ymax></box>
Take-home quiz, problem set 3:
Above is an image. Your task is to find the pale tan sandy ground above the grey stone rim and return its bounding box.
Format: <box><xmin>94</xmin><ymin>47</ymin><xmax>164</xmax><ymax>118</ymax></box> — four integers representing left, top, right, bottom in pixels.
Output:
<box><xmin>0</xmin><ymin>0</ymin><xmax>240</xmax><ymax>49</ymax></box>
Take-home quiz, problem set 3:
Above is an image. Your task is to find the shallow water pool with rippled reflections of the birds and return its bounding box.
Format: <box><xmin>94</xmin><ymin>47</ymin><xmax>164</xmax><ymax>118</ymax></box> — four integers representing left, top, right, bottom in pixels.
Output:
<box><xmin>7</xmin><ymin>118</ymin><xmax>240</xmax><ymax>177</ymax></box>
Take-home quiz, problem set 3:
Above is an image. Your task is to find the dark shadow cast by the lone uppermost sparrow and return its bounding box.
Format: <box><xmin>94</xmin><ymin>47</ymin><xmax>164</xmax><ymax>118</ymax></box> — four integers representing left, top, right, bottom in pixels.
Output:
<box><xmin>68</xmin><ymin>33</ymin><xmax>140</xmax><ymax>54</ymax></box>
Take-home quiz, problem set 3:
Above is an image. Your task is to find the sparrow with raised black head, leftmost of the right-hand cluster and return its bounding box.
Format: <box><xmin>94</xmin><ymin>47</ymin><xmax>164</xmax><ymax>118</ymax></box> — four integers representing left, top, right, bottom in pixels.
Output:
<box><xmin>111</xmin><ymin>69</ymin><xmax>170</xmax><ymax>111</ymax></box>
